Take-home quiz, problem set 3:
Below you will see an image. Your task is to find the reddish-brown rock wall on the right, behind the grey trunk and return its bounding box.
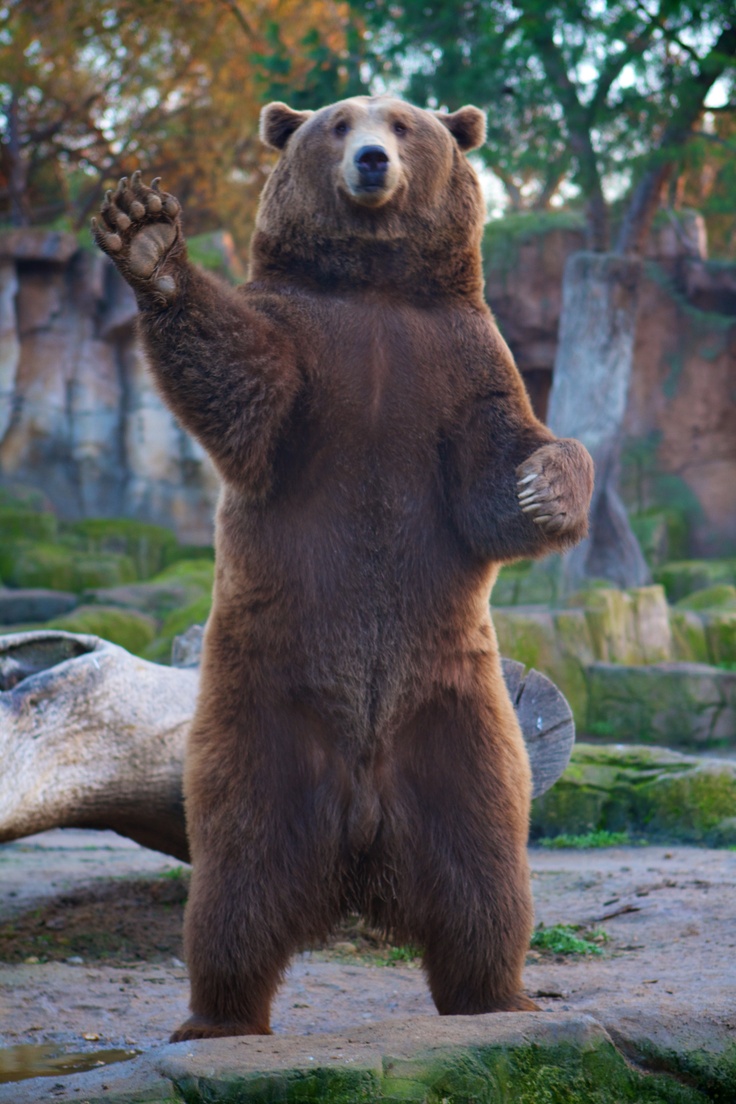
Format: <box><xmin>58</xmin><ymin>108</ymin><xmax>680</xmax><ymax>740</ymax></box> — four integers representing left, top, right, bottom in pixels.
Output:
<box><xmin>486</xmin><ymin>223</ymin><xmax>736</xmax><ymax>556</ymax></box>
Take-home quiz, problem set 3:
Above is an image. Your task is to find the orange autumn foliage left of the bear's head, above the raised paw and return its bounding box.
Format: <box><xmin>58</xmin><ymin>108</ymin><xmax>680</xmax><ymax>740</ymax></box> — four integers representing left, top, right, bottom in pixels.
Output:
<box><xmin>0</xmin><ymin>0</ymin><xmax>364</xmax><ymax>245</ymax></box>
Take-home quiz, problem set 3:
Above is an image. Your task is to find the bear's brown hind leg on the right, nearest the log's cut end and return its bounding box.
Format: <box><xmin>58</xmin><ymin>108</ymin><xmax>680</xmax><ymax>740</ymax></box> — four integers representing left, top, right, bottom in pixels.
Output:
<box><xmin>392</xmin><ymin>693</ymin><xmax>537</xmax><ymax>1016</ymax></box>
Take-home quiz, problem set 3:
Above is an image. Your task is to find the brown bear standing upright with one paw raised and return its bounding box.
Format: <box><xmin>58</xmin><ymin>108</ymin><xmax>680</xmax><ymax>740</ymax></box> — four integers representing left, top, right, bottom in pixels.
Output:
<box><xmin>95</xmin><ymin>97</ymin><xmax>593</xmax><ymax>1040</ymax></box>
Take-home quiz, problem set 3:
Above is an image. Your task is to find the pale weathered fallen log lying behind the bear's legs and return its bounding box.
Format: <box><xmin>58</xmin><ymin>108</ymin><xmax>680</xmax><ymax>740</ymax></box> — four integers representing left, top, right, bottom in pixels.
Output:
<box><xmin>0</xmin><ymin>630</ymin><xmax>575</xmax><ymax>861</ymax></box>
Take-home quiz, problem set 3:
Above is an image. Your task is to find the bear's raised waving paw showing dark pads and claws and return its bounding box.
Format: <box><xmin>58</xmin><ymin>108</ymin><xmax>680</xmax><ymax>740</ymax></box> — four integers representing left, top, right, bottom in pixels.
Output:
<box><xmin>92</xmin><ymin>172</ymin><xmax>183</xmax><ymax>300</ymax></box>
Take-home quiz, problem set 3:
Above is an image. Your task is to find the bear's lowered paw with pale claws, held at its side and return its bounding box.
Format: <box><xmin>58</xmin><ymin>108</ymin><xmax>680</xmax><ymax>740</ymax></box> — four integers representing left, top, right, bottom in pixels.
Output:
<box><xmin>516</xmin><ymin>438</ymin><xmax>594</xmax><ymax>545</ymax></box>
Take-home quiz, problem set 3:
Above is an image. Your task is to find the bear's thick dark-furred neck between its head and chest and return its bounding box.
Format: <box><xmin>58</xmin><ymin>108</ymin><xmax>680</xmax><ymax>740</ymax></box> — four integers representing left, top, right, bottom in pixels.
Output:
<box><xmin>249</xmin><ymin>230</ymin><xmax>483</xmax><ymax>306</ymax></box>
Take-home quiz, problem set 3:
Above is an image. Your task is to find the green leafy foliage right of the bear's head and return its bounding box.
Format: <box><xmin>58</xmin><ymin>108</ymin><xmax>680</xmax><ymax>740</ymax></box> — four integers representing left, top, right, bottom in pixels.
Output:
<box><xmin>360</xmin><ymin>0</ymin><xmax>736</xmax><ymax>252</ymax></box>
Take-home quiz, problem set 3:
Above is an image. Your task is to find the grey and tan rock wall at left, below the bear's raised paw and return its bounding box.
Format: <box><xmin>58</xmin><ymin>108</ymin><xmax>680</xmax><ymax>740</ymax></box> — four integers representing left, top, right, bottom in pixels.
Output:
<box><xmin>0</xmin><ymin>230</ymin><xmax>217</xmax><ymax>543</ymax></box>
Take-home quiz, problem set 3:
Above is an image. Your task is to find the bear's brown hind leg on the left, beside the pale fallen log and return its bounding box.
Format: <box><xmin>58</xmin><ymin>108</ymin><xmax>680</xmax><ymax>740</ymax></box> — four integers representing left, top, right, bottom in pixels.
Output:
<box><xmin>171</xmin><ymin>705</ymin><xmax>341</xmax><ymax>1042</ymax></box>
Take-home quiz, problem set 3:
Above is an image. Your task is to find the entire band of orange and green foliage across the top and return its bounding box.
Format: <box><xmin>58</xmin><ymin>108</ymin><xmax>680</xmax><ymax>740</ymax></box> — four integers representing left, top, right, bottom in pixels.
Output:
<box><xmin>0</xmin><ymin>0</ymin><xmax>736</xmax><ymax>252</ymax></box>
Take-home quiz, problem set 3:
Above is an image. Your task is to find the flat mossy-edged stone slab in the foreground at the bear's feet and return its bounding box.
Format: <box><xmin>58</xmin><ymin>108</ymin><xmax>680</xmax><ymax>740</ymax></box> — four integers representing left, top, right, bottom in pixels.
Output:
<box><xmin>0</xmin><ymin>1012</ymin><xmax>707</xmax><ymax>1104</ymax></box>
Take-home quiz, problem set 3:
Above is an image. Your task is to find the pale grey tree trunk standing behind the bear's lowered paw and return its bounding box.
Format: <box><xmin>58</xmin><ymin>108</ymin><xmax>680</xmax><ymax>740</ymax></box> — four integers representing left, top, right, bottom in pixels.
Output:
<box><xmin>547</xmin><ymin>253</ymin><xmax>649</xmax><ymax>593</ymax></box>
